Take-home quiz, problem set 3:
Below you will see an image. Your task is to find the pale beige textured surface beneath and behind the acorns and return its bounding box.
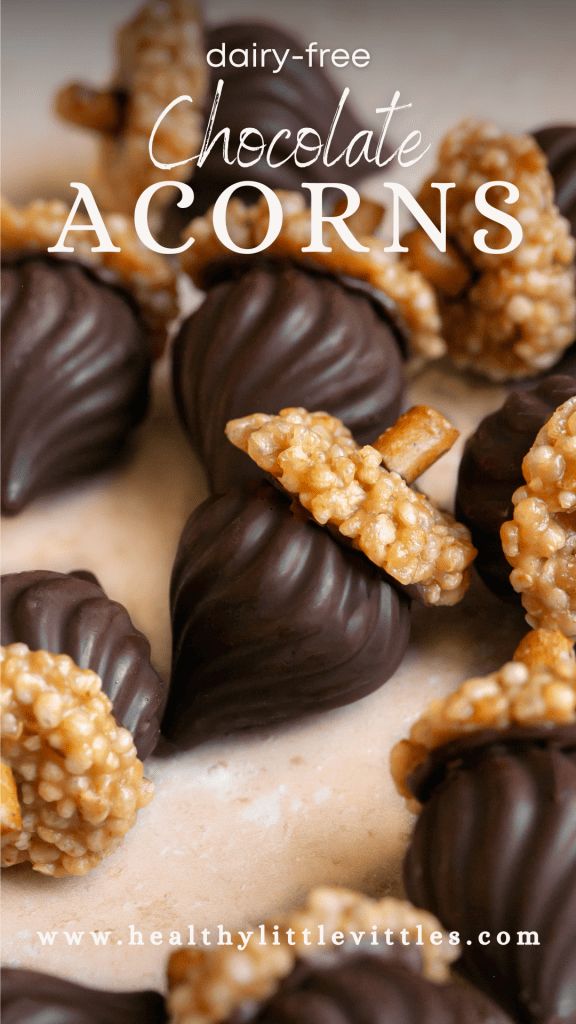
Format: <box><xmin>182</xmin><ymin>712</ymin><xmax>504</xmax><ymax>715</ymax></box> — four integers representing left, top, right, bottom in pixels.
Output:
<box><xmin>3</xmin><ymin>0</ymin><xmax>576</xmax><ymax>988</ymax></box>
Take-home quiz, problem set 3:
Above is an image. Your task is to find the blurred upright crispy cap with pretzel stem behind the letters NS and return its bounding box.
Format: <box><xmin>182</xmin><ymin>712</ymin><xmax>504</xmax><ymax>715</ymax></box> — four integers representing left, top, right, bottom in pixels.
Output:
<box><xmin>404</xmin><ymin>120</ymin><xmax>576</xmax><ymax>380</ymax></box>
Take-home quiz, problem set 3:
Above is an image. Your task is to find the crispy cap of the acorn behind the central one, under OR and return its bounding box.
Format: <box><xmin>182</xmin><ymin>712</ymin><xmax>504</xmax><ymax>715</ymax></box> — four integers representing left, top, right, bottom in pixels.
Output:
<box><xmin>180</xmin><ymin>190</ymin><xmax>445</xmax><ymax>359</ymax></box>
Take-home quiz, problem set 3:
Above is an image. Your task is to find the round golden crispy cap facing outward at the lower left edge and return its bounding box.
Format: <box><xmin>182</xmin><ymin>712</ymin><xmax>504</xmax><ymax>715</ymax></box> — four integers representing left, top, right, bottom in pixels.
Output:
<box><xmin>0</xmin><ymin>643</ymin><xmax>152</xmax><ymax>878</ymax></box>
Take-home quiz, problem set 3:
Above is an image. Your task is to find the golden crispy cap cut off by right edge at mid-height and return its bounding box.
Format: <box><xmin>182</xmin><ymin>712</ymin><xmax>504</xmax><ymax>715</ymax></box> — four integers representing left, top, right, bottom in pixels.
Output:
<box><xmin>500</xmin><ymin>395</ymin><xmax>576</xmax><ymax>637</ymax></box>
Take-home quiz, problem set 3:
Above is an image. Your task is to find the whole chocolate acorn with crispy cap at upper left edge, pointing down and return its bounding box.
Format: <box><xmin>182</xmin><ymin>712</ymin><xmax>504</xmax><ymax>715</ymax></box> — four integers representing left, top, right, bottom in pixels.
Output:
<box><xmin>2</xmin><ymin>196</ymin><xmax>173</xmax><ymax>514</ymax></box>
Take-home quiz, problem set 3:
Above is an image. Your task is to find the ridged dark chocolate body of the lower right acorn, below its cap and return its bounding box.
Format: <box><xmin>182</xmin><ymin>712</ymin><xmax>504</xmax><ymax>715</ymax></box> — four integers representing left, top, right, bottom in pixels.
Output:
<box><xmin>405</xmin><ymin>729</ymin><xmax>576</xmax><ymax>1024</ymax></box>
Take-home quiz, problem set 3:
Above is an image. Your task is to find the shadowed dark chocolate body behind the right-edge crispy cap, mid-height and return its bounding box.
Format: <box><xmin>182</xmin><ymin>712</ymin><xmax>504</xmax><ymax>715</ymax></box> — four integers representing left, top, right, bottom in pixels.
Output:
<box><xmin>456</xmin><ymin>376</ymin><xmax>576</xmax><ymax>599</ymax></box>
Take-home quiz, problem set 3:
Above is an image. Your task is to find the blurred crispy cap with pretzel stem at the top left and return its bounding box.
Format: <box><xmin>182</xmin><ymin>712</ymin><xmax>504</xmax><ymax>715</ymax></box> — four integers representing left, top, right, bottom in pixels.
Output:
<box><xmin>55</xmin><ymin>0</ymin><xmax>208</xmax><ymax>224</ymax></box>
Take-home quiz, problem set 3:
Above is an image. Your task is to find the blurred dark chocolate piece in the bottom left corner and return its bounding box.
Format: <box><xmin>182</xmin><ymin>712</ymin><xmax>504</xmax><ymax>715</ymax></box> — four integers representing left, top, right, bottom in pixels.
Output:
<box><xmin>1</xmin><ymin>968</ymin><xmax>168</xmax><ymax>1024</ymax></box>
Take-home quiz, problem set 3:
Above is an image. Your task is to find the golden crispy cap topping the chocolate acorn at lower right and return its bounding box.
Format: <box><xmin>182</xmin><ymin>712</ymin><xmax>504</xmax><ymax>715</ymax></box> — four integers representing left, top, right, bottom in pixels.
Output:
<box><xmin>390</xmin><ymin>630</ymin><xmax>576</xmax><ymax>810</ymax></box>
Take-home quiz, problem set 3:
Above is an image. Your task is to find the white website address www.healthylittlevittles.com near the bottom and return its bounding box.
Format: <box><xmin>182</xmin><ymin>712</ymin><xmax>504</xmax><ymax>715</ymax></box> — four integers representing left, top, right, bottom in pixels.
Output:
<box><xmin>36</xmin><ymin>924</ymin><xmax>540</xmax><ymax>953</ymax></box>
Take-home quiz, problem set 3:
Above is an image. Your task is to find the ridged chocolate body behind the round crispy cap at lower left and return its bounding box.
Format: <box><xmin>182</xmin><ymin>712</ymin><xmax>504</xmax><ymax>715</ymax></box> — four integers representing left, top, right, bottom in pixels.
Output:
<box><xmin>0</xmin><ymin>570</ymin><xmax>166</xmax><ymax>758</ymax></box>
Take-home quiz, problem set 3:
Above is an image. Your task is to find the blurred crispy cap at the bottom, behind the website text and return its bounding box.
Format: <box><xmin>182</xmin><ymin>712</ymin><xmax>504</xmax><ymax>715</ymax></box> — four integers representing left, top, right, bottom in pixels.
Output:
<box><xmin>168</xmin><ymin>888</ymin><xmax>459</xmax><ymax>1024</ymax></box>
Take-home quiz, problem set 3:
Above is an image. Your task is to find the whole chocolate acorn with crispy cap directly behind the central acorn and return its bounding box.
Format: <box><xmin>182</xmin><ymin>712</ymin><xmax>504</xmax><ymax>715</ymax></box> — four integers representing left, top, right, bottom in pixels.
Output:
<box><xmin>173</xmin><ymin>193</ymin><xmax>442</xmax><ymax>492</ymax></box>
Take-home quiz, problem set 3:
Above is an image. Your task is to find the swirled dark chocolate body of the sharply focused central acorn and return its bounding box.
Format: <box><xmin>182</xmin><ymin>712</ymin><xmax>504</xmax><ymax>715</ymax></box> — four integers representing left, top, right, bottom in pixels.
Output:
<box><xmin>163</xmin><ymin>483</ymin><xmax>410</xmax><ymax>748</ymax></box>
